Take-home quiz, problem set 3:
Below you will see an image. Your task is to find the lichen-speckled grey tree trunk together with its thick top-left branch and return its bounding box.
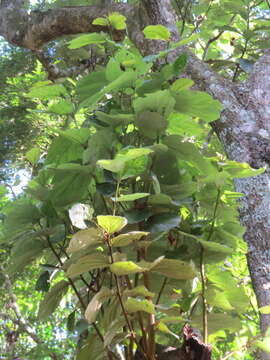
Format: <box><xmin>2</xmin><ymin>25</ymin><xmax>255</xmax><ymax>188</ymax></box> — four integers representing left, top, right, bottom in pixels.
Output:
<box><xmin>0</xmin><ymin>0</ymin><xmax>270</xmax><ymax>360</ymax></box>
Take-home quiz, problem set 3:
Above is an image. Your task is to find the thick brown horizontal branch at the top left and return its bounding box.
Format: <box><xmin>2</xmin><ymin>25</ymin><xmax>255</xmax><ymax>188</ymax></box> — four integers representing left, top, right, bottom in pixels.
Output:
<box><xmin>0</xmin><ymin>0</ymin><xmax>134</xmax><ymax>50</ymax></box>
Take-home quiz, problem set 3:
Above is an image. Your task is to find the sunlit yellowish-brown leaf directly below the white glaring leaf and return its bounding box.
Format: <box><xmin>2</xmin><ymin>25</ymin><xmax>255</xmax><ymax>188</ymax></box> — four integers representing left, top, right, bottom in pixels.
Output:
<box><xmin>67</xmin><ymin>227</ymin><xmax>103</xmax><ymax>253</ymax></box>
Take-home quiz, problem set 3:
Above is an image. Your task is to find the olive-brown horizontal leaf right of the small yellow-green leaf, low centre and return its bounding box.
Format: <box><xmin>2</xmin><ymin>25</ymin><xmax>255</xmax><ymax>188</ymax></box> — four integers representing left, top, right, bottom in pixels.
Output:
<box><xmin>151</xmin><ymin>259</ymin><xmax>196</xmax><ymax>280</ymax></box>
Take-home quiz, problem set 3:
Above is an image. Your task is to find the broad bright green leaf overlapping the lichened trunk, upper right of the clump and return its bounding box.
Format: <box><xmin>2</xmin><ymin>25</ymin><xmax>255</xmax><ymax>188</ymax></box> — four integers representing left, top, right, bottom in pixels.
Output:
<box><xmin>174</xmin><ymin>90</ymin><xmax>222</xmax><ymax>122</ymax></box>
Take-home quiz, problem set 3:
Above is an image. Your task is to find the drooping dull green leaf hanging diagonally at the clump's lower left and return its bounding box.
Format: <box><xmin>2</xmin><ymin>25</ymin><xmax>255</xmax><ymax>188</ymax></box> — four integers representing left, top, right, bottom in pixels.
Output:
<box><xmin>38</xmin><ymin>280</ymin><xmax>69</xmax><ymax>320</ymax></box>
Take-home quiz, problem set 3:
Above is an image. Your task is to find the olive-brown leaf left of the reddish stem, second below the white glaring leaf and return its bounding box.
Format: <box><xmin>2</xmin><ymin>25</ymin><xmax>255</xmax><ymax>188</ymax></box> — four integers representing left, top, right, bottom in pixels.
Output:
<box><xmin>67</xmin><ymin>253</ymin><xmax>109</xmax><ymax>277</ymax></box>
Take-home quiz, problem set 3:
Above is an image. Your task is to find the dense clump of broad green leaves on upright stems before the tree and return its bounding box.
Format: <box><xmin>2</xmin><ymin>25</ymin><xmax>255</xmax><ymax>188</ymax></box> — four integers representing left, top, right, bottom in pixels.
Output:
<box><xmin>1</xmin><ymin>7</ymin><xmax>267</xmax><ymax>360</ymax></box>
